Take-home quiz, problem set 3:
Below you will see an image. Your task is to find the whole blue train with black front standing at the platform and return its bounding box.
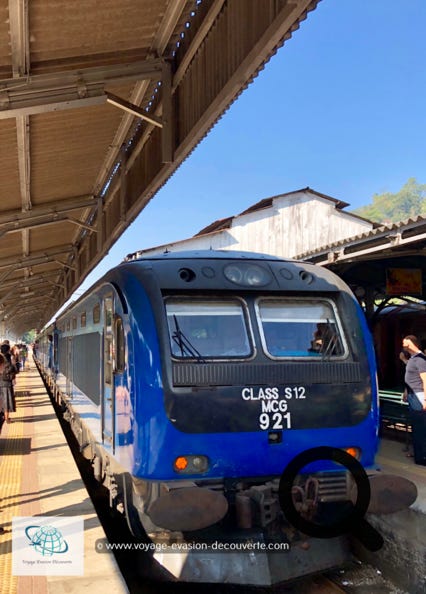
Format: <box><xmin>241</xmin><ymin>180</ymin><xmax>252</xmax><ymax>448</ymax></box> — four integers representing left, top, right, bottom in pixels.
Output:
<box><xmin>37</xmin><ymin>251</ymin><xmax>378</xmax><ymax>584</ymax></box>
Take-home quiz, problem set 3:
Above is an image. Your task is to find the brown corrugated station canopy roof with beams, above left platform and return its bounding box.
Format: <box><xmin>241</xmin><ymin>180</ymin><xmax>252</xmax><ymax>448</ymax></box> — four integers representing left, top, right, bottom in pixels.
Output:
<box><xmin>0</xmin><ymin>0</ymin><xmax>319</xmax><ymax>337</ymax></box>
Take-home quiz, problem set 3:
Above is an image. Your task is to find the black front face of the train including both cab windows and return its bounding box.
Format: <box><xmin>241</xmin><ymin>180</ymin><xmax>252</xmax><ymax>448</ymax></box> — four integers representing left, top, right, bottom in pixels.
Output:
<box><xmin>153</xmin><ymin>256</ymin><xmax>371</xmax><ymax>433</ymax></box>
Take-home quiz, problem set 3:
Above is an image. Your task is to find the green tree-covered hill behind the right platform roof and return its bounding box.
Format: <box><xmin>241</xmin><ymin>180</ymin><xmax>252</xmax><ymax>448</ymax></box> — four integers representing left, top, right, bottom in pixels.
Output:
<box><xmin>352</xmin><ymin>177</ymin><xmax>426</xmax><ymax>223</ymax></box>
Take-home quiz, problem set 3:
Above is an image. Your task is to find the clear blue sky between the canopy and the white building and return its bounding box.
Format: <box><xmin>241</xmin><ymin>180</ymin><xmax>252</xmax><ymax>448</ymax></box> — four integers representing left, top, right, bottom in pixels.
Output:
<box><xmin>74</xmin><ymin>0</ymin><xmax>426</xmax><ymax>294</ymax></box>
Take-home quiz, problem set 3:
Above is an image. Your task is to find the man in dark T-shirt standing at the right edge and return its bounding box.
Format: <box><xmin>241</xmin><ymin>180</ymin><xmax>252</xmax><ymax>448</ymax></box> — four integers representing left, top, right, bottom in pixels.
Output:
<box><xmin>402</xmin><ymin>334</ymin><xmax>426</xmax><ymax>466</ymax></box>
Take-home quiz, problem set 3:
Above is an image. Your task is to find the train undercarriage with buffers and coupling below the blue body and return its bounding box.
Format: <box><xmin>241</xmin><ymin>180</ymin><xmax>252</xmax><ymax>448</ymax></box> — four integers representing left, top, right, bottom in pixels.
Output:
<box><xmin>41</xmin><ymin>370</ymin><xmax>416</xmax><ymax>586</ymax></box>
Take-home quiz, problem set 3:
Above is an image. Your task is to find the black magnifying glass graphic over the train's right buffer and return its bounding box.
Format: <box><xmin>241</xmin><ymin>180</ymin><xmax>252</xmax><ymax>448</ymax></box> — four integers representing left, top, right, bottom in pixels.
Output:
<box><xmin>278</xmin><ymin>446</ymin><xmax>383</xmax><ymax>551</ymax></box>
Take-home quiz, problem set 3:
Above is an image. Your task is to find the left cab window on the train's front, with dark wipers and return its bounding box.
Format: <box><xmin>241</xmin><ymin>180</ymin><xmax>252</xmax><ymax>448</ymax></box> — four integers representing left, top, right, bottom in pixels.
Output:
<box><xmin>166</xmin><ymin>297</ymin><xmax>252</xmax><ymax>360</ymax></box>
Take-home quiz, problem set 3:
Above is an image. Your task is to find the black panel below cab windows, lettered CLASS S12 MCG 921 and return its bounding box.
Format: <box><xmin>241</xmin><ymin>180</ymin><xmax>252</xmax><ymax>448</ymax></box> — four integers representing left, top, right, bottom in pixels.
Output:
<box><xmin>165</xmin><ymin>362</ymin><xmax>371</xmax><ymax>433</ymax></box>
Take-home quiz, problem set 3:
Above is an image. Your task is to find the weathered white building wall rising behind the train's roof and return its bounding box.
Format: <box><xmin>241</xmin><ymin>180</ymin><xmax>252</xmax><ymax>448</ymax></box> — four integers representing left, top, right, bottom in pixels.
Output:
<box><xmin>137</xmin><ymin>190</ymin><xmax>373</xmax><ymax>258</ymax></box>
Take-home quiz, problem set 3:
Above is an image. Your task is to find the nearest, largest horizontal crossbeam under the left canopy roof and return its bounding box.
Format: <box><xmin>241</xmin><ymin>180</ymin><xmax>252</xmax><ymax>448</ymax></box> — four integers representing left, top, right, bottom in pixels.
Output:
<box><xmin>0</xmin><ymin>59</ymin><xmax>163</xmax><ymax>119</ymax></box>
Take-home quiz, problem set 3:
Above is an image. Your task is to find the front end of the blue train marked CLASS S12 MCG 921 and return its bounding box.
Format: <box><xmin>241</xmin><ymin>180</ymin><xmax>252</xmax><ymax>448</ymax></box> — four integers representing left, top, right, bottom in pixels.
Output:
<box><xmin>125</xmin><ymin>252</ymin><xmax>378</xmax><ymax>584</ymax></box>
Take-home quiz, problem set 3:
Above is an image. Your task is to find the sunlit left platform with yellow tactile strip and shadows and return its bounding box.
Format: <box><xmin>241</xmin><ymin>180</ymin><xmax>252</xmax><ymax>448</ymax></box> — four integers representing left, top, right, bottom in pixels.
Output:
<box><xmin>0</xmin><ymin>361</ymin><xmax>128</xmax><ymax>594</ymax></box>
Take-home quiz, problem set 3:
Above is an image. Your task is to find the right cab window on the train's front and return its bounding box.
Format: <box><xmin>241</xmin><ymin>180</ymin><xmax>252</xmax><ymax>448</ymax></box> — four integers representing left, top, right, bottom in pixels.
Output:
<box><xmin>256</xmin><ymin>298</ymin><xmax>346</xmax><ymax>359</ymax></box>
